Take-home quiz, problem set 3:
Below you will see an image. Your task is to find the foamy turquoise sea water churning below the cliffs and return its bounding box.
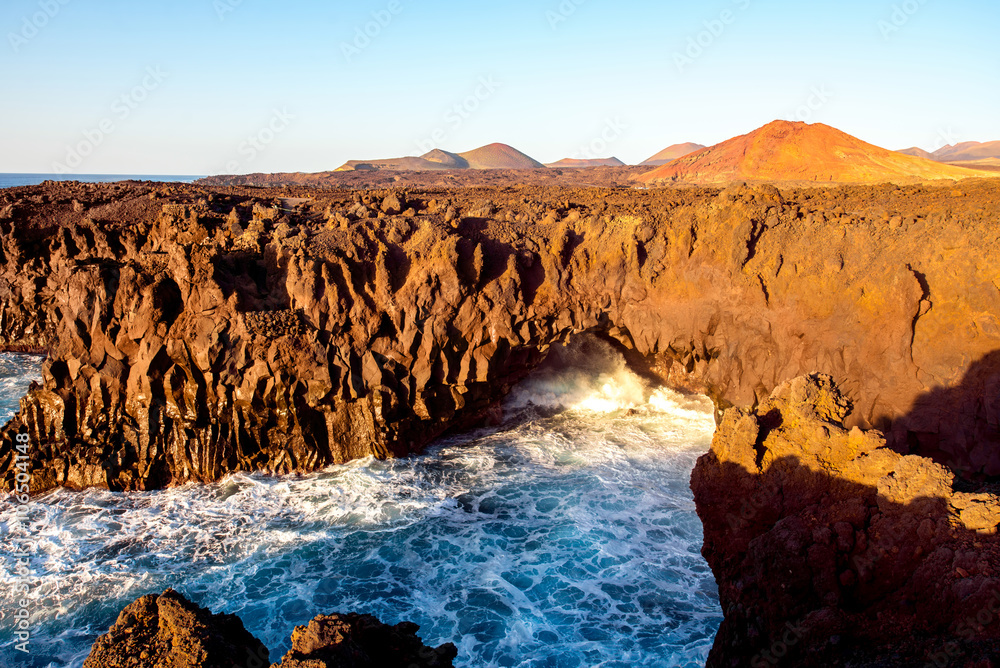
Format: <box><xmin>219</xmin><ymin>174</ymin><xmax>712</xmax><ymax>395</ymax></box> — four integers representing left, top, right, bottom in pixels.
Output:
<box><xmin>0</xmin><ymin>350</ymin><xmax>721</xmax><ymax>668</ymax></box>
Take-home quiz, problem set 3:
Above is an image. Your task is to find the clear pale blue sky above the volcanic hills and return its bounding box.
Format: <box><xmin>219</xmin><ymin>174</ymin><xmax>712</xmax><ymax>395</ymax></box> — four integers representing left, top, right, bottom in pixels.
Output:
<box><xmin>0</xmin><ymin>0</ymin><xmax>1000</xmax><ymax>174</ymax></box>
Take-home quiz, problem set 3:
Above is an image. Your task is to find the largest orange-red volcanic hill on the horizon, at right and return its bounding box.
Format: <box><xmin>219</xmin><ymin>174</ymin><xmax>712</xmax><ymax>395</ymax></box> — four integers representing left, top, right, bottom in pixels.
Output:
<box><xmin>637</xmin><ymin>121</ymin><xmax>985</xmax><ymax>184</ymax></box>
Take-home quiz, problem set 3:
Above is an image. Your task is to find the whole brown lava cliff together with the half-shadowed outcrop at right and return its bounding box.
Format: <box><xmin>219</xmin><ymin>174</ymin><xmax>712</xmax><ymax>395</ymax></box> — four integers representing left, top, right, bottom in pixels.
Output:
<box><xmin>0</xmin><ymin>180</ymin><xmax>1000</xmax><ymax>666</ymax></box>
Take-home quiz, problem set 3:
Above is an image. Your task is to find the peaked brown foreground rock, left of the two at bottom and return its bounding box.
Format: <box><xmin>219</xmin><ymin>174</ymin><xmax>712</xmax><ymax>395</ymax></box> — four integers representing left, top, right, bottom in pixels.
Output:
<box><xmin>83</xmin><ymin>589</ymin><xmax>270</xmax><ymax>668</ymax></box>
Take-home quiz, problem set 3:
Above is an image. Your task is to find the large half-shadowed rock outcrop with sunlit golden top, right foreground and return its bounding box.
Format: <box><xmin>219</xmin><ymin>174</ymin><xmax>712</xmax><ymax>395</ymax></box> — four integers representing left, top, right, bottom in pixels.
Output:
<box><xmin>691</xmin><ymin>375</ymin><xmax>1000</xmax><ymax>668</ymax></box>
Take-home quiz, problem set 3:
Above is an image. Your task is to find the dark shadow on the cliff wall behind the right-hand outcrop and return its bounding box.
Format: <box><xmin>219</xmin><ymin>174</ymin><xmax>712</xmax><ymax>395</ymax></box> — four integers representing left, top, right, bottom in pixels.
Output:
<box><xmin>876</xmin><ymin>350</ymin><xmax>1000</xmax><ymax>482</ymax></box>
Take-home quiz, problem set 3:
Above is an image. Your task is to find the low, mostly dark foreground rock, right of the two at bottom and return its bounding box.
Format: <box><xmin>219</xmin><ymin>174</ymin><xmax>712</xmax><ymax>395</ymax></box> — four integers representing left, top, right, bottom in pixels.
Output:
<box><xmin>275</xmin><ymin>614</ymin><xmax>458</xmax><ymax>668</ymax></box>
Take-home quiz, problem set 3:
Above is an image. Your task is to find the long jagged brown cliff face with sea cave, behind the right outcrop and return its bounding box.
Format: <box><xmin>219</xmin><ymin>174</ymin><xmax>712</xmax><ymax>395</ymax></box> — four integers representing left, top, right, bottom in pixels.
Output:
<box><xmin>0</xmin><ymin>177</ymin><xmax>1000</xmax><ymax>492</ymax></box>
